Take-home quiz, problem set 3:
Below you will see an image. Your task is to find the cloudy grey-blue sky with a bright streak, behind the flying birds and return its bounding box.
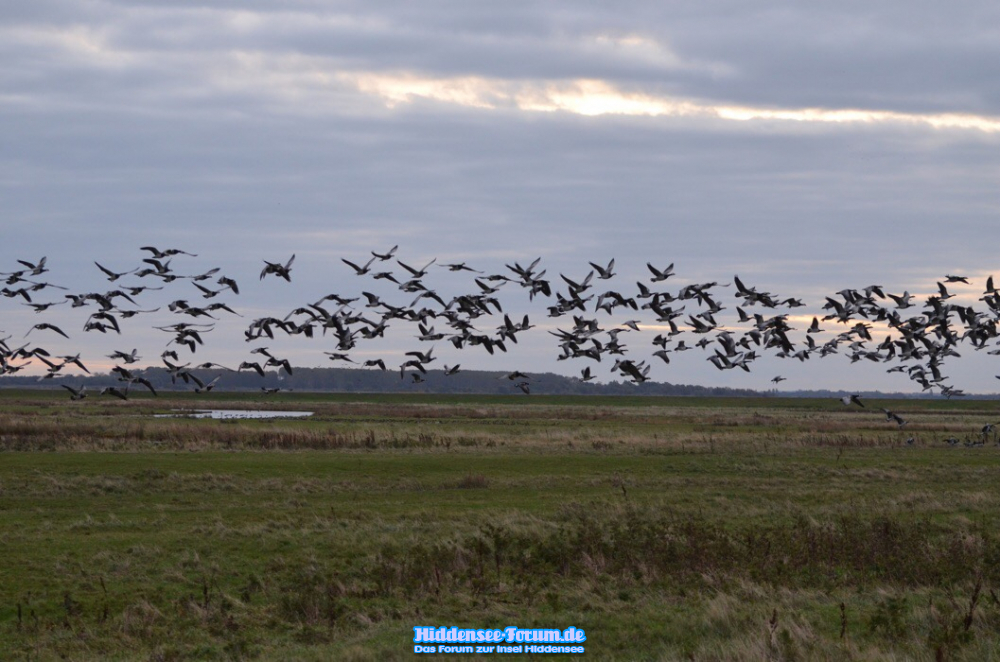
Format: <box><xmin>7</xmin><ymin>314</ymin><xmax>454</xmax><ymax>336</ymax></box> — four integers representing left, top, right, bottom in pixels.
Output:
<box><xmin>0</xmin><ymin>0</ymin><xmax>1000</xmax><ymax>392</ymax></box>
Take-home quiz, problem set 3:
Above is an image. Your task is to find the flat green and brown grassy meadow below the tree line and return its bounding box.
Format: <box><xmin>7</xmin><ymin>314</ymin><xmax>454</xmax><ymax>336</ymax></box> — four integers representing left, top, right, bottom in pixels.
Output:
<box><xmin>0</xmin><ymin>391</ymin><xmax>1000</xmax><ymax>660</ymax></box>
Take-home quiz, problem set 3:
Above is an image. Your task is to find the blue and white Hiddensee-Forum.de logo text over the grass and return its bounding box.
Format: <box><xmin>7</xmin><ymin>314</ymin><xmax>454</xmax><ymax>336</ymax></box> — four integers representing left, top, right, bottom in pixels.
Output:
<box><xmin>413</xmin><ymin>626</ymin><xmax>587</xmax><ymax>654</ymax></box>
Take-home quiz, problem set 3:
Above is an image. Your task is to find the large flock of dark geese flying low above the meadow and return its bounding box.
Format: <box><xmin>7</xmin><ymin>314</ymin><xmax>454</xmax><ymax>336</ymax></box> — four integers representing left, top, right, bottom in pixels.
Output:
<box><xmin>0</xmin><ymin>246</ymin><xmax>1000</xmax><ymax>426</ymax></box>
